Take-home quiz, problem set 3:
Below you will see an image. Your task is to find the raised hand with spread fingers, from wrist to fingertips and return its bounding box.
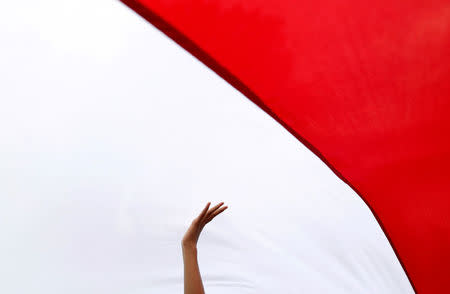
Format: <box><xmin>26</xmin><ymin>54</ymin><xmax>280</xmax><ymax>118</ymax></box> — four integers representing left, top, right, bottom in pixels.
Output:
<box><xmin>181</xmin><ymin>202</ymin><xmax>228</xmax><ymax>248</ymax></box>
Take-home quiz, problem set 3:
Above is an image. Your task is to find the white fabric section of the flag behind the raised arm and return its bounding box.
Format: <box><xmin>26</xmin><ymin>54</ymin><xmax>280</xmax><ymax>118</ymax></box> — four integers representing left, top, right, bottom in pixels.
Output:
<box><xmin>0</xmin><ymin>0</ymin><xmax>413</xmax><ymax>294</ymax></box>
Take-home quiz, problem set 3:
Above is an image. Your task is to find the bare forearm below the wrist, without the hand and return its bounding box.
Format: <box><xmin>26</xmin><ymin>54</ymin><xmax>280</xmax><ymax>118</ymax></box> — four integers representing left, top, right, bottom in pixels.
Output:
<box><xmin>182</xmin><ymin>244</ymin><xmax>205</xmax><ymax>294</ymax></box>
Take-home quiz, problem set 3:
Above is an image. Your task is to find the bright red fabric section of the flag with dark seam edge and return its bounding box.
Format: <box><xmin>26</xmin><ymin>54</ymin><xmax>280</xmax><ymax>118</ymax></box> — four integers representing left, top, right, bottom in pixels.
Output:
<box><xmin>119</xmin><ymin>0</ymin><xmax>450</xmax><ymax>293</ymax></box>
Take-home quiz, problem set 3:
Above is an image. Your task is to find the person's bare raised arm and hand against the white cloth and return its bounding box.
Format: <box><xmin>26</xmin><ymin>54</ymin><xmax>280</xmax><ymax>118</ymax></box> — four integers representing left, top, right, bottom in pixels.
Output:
<box><xmin>181</xmin><ymin>202</ymin><xmax>228</xmax><ymax>294</ymax></box>
